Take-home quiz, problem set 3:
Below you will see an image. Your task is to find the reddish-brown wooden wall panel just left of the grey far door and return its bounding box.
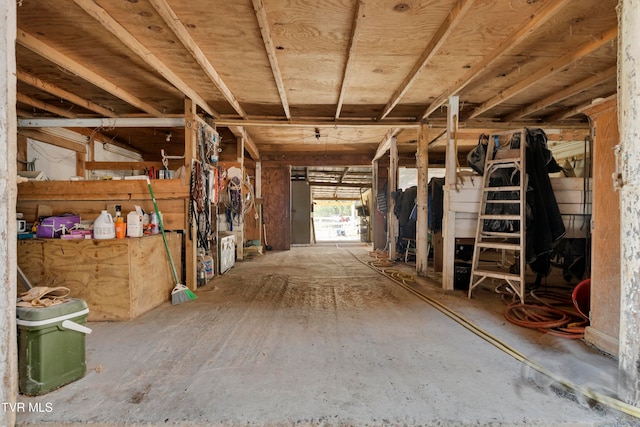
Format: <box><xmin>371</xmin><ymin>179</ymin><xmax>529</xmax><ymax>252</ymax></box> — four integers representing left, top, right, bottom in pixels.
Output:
<box><xmin>262</xmin><ymin>162</ymin><xmax>291</xmax><ymax>250</ymax></box>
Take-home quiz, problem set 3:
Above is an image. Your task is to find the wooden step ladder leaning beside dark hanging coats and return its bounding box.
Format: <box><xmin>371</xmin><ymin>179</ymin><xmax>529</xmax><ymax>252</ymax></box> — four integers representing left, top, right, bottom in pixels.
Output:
<box><xmin>469</xmin><ymin>129</ymin><xmax>527</xmax><ymax>302</ymax></box>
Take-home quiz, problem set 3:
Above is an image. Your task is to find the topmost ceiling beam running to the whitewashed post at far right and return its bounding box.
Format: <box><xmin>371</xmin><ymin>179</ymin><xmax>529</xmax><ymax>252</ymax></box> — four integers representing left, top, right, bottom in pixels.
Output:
<box><xmin>469</xmin><ymin>26</ymin><xmax>618</xmax><ymax>119</ymax></box>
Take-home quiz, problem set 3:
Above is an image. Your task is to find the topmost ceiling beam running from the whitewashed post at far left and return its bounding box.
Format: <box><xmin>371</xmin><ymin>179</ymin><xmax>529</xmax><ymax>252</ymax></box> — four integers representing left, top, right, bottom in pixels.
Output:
<box><xmin>16</xmin><ymin>29</ymin><xmax>163</xmax><ymax>117</ymax></box>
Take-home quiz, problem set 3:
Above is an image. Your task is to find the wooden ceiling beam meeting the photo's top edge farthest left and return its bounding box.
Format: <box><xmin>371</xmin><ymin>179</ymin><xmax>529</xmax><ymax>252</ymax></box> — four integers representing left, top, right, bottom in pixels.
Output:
<box><xmin>74</xmin><ymin>0</ymin><xmax>219</xmax><ymax>117</ymax></box>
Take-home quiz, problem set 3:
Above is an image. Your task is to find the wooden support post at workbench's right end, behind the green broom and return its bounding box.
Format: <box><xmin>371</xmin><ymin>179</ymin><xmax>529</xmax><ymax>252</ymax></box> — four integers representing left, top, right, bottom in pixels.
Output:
<box><xmin>184</xmin><ymin>98</ymin><xmax>198</xmax><ymax>289</ymax></box>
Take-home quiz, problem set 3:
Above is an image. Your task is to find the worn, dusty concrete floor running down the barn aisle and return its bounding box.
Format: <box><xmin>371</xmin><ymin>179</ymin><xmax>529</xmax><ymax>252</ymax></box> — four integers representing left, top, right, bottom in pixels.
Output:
<box><xmin>18</xmin><ymin>244</ymin><xmax>639</xmax><ymax>426</ymax></box>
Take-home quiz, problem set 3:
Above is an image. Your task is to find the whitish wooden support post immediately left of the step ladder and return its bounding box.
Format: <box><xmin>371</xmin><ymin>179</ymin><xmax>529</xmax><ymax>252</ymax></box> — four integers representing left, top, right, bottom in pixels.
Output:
<box><xmin>442</xmin><ymin>96</ymin><xmax>459</xmax><ymax>290</ymax></box>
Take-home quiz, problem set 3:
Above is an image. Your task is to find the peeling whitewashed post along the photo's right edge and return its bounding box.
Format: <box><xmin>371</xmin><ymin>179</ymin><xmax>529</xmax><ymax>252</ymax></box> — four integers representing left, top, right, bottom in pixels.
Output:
<box><xmin>613</xmin><ymin>0</ymin><xmax>640</xmax><ymax>406</ymax></box>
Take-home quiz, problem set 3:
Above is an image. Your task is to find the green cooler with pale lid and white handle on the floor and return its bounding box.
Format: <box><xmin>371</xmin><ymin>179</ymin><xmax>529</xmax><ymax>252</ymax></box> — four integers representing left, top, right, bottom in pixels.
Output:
<box><xmin>16</xmin><ymin>299</ymin><xmax>91</xmax><ymax>396</ymax></box>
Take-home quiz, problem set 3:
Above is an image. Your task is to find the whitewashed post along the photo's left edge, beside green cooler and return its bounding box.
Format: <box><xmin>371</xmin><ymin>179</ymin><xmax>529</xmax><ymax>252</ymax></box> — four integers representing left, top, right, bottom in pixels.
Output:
<box><xmin>0</xmin><ymin>1</ymin><xmax>18</xmax><ymax>426</ymax></box>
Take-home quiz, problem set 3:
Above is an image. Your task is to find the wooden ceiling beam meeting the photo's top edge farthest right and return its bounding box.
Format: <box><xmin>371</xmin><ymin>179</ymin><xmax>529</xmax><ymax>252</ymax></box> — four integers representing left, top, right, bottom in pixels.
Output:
<box><xmin>422</xmin><ymin>0</ymin><xmax>571</xmax><ymax>119</ymax></box>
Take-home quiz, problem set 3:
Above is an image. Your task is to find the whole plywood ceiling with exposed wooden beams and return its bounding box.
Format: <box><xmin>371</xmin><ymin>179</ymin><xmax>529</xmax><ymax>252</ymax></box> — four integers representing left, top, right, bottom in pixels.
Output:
<box><xmin>16</xmin><ymin>0</ymin><xmax>617</xmax><ymax>165</ymax></box>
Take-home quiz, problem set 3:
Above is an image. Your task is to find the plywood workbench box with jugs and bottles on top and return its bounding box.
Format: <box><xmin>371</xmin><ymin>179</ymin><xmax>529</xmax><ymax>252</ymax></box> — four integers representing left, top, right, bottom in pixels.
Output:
<box><xmin>18</xmin><ymin>233</ymin><xmax>182</xmax><ymax>321</ymax></box>
